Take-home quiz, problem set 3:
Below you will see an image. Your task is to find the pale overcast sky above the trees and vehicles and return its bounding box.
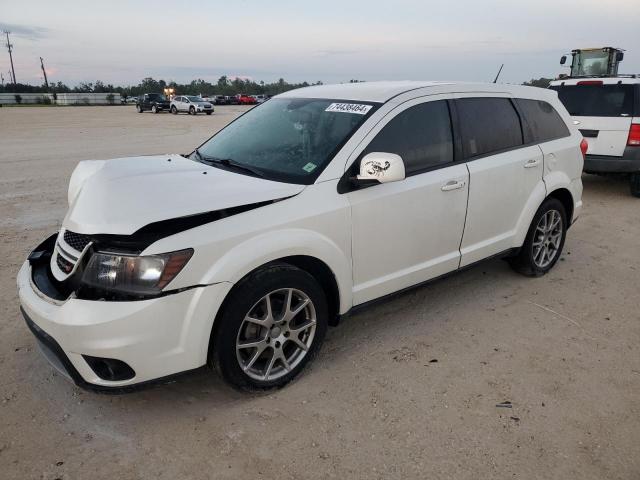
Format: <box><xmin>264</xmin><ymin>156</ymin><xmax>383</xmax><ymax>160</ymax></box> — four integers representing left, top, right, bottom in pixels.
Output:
<box><xmin>0</xmin><ymin>0</ymin><xmax>640</xmax><ymax>85</ymax></box>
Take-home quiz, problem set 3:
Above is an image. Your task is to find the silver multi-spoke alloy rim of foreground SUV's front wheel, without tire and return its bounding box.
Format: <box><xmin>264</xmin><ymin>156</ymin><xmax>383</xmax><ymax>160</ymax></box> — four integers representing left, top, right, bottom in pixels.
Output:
<box><xmin>236</xmin><ymin>288</ymin><xmax>317</xmax><ymax>381</ymax></box>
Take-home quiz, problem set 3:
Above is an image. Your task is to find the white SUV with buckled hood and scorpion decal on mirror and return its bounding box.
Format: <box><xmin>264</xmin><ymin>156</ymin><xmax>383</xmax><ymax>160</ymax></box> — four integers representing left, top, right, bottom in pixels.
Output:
<box><xmin>18</xmin><ymin>82</ymin><xmax>583</xmax><ymax>389</ymax></box>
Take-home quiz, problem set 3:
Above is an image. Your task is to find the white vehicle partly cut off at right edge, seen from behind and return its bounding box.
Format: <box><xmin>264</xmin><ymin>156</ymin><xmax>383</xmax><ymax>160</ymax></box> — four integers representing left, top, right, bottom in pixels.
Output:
<box><xmin>549</xmin><ymin>75</ymin><xmax>640</xmax><ymax>197</ymax></box>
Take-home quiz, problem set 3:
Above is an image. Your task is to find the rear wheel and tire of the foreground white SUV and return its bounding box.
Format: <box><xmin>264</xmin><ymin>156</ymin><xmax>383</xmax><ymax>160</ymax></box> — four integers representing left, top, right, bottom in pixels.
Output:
<box><xmin>509</xmin><ymin>198</ymin><xmax>568</xmax><ymax>277</ymax></box>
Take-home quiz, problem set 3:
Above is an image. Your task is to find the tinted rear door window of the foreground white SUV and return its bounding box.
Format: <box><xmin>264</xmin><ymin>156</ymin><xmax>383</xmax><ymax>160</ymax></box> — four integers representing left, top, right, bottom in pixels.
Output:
<box><xmin>456</xmin><ymin>98</ymin><xmax>523</xmax><ymax>158</ymax></box>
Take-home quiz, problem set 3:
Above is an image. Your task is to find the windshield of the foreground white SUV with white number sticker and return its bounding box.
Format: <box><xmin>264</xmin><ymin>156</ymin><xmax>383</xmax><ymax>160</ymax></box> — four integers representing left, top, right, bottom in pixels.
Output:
<box><xmin>194</xmin><ymin>98</ymin><xmax>376</xmax><ymax>184</ymax></box>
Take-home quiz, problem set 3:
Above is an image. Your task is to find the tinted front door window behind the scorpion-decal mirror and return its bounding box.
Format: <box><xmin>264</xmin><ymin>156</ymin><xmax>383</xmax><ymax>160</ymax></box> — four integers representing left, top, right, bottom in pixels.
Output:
<box><xmin>361</xmin><ymin>100</ymin><xmax>453</xmax><ymax>175</ymax></box>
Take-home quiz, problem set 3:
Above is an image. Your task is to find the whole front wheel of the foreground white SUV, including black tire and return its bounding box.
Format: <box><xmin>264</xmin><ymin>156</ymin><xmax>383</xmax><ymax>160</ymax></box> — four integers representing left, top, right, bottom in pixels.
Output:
<box><xmin>209</xmin><ymin>264</ymin><xmax>328</xmax><ymax>390</ymax></box>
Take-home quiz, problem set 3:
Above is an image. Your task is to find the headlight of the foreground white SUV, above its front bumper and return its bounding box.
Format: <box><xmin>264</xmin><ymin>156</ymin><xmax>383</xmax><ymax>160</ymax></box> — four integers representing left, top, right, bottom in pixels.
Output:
<box><xmin>82</xmin><ymin>249</ymin><xmax>193</xmax><ymax>295</ymax></box>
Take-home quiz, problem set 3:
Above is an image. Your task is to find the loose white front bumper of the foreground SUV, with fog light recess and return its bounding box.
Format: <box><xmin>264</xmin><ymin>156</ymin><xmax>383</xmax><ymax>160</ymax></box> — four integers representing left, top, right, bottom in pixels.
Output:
<box><xmin>17</xmin><ymin>235</ymin><xmax>231</xmax><ymax>391</ymax></box>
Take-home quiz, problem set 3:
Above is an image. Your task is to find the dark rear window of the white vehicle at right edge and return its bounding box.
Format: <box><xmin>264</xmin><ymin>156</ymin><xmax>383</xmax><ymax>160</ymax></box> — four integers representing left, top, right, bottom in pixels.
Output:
<box><xmin>549</xmin><ymin>84</ymin><xmax>634</xmax><ymax>117</ymax></box>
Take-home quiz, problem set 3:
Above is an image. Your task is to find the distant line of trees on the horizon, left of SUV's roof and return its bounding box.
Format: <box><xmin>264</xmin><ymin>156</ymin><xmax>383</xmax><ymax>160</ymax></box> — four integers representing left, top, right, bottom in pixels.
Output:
<box><xmin>0</xmin><ymin>75</ymin><xmax>322</xmax><ymax>97</ymax></box>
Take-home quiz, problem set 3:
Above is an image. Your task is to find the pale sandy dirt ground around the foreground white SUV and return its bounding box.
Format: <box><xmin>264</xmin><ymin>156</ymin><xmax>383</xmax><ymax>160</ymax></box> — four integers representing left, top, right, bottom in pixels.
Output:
<box><xmin>0</xmin><ymin>107</ymin><xmax>640</xmax><ymax>480</ymax></box>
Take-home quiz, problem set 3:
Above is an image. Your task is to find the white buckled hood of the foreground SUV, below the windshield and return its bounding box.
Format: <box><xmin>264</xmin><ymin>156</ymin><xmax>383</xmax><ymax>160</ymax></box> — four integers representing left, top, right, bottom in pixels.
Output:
<box><xmin>63</xmin><ymin>155</ymin><xmax>305</xmax><ymax>235</ymax></box>
